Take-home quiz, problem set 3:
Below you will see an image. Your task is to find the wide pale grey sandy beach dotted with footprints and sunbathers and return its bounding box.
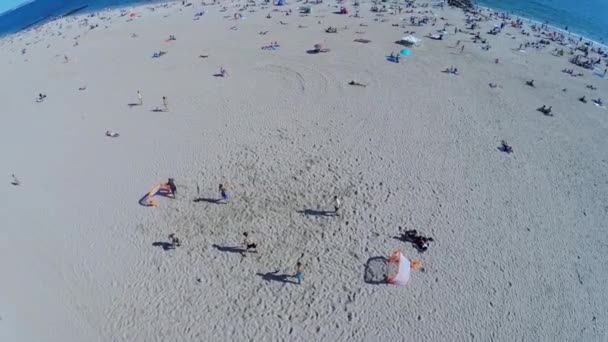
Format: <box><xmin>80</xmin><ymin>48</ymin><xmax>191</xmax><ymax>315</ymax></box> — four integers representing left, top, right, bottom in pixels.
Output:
<box><xmin>0</xmin><ymin>2</ymin><xmax>608</xmax><ymax>341</ymax></box>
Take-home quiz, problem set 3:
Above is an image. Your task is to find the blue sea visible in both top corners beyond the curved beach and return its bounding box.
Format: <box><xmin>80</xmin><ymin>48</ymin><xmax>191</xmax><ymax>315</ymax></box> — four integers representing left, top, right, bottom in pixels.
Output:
<box><xmin>0</xmin><ymin>0</ymin><xmax>608</xmax><ymax>44</ymax></box>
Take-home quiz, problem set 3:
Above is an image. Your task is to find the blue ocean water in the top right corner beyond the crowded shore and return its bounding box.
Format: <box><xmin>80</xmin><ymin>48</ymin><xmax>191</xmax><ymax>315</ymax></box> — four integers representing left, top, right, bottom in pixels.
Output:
<box><xmin>480</xmin><ymin>0</ymin><xmax>608</xmax><ymax>45</ymax></box>
